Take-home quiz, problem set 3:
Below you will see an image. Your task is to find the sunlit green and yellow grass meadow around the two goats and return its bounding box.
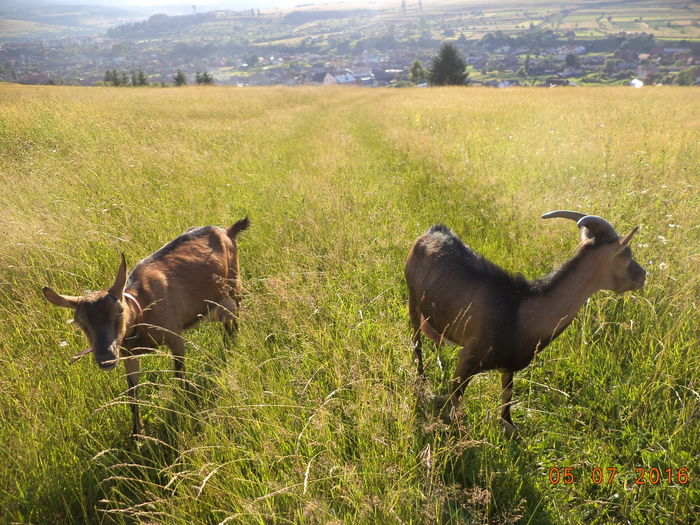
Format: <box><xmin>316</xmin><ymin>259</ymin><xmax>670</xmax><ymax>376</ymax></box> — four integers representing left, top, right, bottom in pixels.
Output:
<box><xmin>0</xmin><ymin>85</ymin><xmax>700</xmax><ymax>525</ymax></box>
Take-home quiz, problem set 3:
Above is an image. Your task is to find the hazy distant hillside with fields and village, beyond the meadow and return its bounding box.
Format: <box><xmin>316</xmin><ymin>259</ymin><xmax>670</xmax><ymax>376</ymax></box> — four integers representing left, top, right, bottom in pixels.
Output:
<box><xmin>0</xmin><ymin>0</ymin><xmax>700</xmax><ymax>86</ymax></box>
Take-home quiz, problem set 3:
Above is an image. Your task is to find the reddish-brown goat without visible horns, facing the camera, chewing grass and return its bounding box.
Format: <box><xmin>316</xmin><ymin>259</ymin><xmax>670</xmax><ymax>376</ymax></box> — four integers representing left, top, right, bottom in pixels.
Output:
<box><xmin>43</xmin><ymin>217</ymin><xmax>250</xmax><ymax>434</ymax></box>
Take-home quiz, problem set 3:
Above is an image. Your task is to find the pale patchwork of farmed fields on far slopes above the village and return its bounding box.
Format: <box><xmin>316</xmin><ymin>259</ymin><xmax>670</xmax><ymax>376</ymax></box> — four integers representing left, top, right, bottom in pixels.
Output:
<box><xmin>0</xmin><ymin>0</ymin><xmax>700</xmax><ymax>42</ymax></box>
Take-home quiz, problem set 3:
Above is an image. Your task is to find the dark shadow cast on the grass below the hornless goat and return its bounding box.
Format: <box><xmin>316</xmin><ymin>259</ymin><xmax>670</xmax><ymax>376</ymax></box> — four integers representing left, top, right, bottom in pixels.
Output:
<box><xmin>73</xmin><ymin>334</ymin><xmax>233</xmax><ymax>524</ymax></box>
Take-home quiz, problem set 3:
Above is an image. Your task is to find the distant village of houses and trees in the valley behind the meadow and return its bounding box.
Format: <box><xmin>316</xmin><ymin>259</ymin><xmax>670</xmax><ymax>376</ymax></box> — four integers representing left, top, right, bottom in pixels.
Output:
<box><xmin>0</xmin><ymin>11</ymin><xmax>700</xmax><ymax>87</ymax></box>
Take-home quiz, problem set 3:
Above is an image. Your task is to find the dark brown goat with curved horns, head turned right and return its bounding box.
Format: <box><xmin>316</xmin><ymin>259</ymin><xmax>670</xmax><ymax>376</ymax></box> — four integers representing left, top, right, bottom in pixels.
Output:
<box><xmin>405</xmin><ymin>211</ymin><xmax>646</xmax><ymax>436</ymax></box>
